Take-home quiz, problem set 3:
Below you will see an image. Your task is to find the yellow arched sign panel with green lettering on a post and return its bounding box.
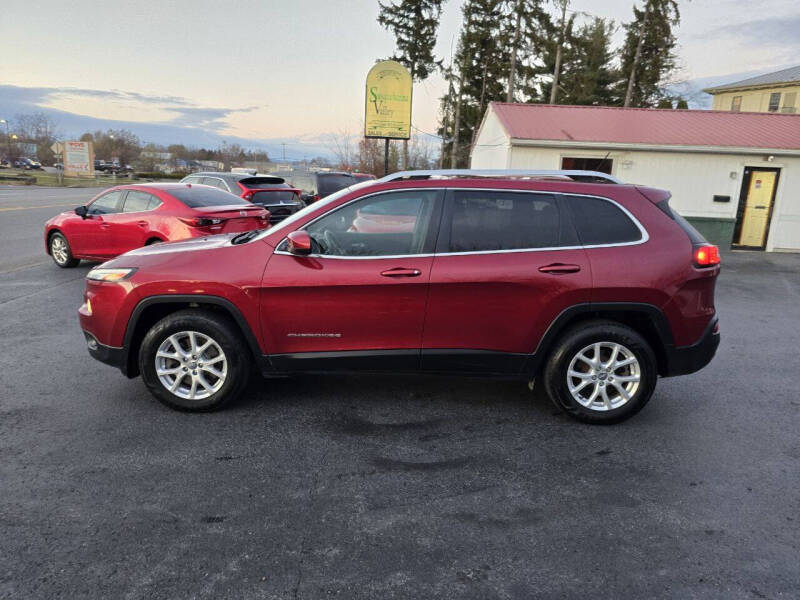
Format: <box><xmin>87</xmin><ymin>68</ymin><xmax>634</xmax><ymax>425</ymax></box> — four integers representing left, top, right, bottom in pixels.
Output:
<box><xmin>364</xmin><ymin>60</ymin><xmax>412</xmax><ymax>140</ymax></box>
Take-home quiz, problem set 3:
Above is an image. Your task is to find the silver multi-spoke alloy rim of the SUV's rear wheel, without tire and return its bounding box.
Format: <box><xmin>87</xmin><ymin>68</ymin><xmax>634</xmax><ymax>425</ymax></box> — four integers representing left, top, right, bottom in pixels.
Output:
<box><xmin>567</xmin><ymin>342</ymin><xmax>642</xmax><ymax>411</ymax></box>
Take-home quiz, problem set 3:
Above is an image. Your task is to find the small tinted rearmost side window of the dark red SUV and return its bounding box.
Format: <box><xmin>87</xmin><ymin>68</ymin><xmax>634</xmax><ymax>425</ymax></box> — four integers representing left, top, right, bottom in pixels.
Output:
<box><xmin>564</xmin><ymin>196</ymin><xmax>642</xmax><ymax>246</ymax></box>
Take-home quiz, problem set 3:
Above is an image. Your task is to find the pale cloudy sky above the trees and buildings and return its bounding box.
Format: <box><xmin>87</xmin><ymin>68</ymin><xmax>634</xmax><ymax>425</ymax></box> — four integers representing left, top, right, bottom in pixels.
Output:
<box><xmin>0</xmin><ymin>0</ymin><xmax>800</xmax><ymax>149</ymax></box>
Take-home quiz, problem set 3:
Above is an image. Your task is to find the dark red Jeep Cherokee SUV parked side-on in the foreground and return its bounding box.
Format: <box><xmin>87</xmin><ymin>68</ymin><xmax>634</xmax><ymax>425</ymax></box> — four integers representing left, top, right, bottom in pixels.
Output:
<box><xmin>80</xmin><ymin>171</ymin><xmax>720</xmax><ymax>423</ymax></box>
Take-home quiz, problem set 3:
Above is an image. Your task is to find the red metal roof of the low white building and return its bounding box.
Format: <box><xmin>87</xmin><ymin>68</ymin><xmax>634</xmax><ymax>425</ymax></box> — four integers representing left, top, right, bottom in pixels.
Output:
<box><xmin>491</xmin><ymin>102</ymin><xmax>800</xmax><ymax>150</ymax></box>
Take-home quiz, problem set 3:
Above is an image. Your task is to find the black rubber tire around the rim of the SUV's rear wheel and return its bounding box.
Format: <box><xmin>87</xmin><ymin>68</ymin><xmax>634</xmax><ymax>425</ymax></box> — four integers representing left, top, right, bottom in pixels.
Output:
<box><xmin>544</xmin><ymin>320</ymin><xmax>658</xmax><ymax>425</ymax></box>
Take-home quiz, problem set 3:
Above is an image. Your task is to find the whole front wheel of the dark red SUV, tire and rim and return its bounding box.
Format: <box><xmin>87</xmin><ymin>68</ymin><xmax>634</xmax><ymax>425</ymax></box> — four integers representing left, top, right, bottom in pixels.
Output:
<box><xmin>139</xmin><ymin>310</ymin><xmax>251</xmax><ymax>412</ymax></box>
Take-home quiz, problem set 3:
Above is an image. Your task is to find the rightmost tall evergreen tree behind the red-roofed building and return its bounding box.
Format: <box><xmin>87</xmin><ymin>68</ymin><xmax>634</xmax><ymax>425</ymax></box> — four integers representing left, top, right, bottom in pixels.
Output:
<box><xmin>618</xmin><ymin>0</ymin><xmax>680</xmax><ymax>107</ymax></box>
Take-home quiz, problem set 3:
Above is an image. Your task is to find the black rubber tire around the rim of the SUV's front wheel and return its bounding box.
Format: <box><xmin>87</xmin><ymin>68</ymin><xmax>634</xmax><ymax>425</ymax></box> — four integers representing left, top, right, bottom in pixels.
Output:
<box><xmin>139</xmin><ymin>309</ymin><xmax>252</xmax><ymax>412</ymax></box>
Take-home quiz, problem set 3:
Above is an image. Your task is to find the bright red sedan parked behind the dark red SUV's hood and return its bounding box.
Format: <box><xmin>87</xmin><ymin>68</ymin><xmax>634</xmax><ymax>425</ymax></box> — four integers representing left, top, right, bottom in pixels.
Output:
<box><xmin>44</xmin><ymin>183</ymin><xmax>269</xmax><ymax>268</ymax></box>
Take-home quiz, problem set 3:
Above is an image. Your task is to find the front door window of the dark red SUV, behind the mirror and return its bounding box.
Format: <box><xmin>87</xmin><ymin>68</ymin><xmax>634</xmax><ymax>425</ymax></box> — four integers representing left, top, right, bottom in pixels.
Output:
<box><xmin>307</xmin><ymin>190</ymin><xmax>437</xmax><ymax>256</ymax></box>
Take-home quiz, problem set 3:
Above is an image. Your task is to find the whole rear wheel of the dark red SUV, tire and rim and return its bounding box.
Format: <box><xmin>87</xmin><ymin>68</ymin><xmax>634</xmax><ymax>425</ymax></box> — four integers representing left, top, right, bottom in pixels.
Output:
<box><xmin>544</xmin><ymin>321</ymin><xmax>657</xmax><ymax>423</ymax></box>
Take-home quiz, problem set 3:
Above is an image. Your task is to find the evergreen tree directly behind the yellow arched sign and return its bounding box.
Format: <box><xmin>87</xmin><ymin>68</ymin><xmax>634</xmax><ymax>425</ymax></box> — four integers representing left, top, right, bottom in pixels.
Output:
<box><xmin>378</xmin><ymin>0</ymin><xmax>444</xmax><ymax>168</ymax></box>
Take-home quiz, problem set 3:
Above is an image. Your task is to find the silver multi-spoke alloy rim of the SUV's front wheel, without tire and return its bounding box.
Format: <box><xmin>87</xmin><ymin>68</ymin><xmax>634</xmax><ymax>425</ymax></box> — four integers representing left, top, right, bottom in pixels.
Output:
<box><xmin>155</xmin><ymin>331</ymin><xmax>228</xmax><ymax>400</ymax></box>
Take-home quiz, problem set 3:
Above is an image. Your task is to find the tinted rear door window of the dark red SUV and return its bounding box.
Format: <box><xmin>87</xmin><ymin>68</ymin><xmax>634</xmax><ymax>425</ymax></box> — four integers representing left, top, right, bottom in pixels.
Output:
<box><xmin>449</xmin><ymin>191</ymin><xmax>577</xmax><ymax>252</ymax></box>
